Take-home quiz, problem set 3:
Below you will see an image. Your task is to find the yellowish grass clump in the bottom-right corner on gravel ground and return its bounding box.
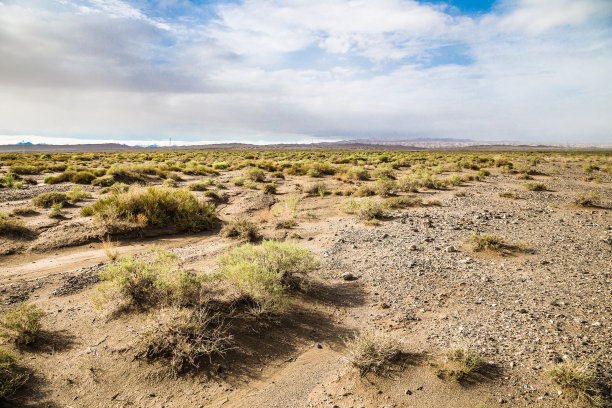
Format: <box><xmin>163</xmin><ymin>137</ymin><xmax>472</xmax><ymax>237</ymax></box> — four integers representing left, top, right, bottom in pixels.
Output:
<box><xmin>547</xmin><ymin>360</ymin><xmax>606</xmax><ymax>407</ymax></box>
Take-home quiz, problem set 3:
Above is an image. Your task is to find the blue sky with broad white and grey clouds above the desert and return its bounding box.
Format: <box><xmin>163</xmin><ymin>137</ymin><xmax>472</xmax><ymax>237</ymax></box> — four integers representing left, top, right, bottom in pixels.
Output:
<box><xmin>0</xmin><ymin>0</ymin><xmax>612</xmax><ymax>144</ymax></box>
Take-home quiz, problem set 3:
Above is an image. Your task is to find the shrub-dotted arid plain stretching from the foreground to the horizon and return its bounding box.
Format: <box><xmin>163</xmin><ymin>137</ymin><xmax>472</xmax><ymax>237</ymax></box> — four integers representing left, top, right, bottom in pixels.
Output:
<box><xmin>0</xmin><ymin>151</ymin><xmax>612</xmax><ymax>408</ymax></box>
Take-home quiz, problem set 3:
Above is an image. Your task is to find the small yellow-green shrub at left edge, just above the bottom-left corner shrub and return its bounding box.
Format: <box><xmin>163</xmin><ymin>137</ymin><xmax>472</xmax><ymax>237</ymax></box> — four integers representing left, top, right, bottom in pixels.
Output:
<box><xmin>0</xmin><ymin>303</ymin><xmax>45</xmax><ymax>346</ymax></box>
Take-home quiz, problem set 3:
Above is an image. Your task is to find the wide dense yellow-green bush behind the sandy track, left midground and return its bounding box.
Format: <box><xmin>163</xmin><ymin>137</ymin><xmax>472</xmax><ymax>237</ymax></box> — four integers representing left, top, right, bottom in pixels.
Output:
<box><xmin>91</xmin><ymin>187</ymin><xmax>217</xmax><ymax>232</ymax></box>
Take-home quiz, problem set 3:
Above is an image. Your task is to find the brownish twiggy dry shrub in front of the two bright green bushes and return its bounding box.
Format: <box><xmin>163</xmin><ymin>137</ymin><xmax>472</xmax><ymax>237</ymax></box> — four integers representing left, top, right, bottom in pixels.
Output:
<box><xmin>135</xmin><ymin>307</ymin><xmax>233</xmax><ymax>375</ymax></box>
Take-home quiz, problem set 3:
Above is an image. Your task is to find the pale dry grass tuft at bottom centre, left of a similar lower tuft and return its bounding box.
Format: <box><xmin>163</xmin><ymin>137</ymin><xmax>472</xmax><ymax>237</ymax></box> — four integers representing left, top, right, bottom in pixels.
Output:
<box><xmin>346</xmin><ymin>330</ymin><xmax>402</xmax><ymax>377</ymax></box>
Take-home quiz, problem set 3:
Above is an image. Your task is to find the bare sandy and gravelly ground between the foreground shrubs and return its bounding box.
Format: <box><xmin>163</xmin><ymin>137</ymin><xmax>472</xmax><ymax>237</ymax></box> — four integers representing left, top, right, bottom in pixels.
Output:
<box><xmin>0</xmin><ymin>159</ymin><xmax>612</xmax><ymax>408</ymax></box>
